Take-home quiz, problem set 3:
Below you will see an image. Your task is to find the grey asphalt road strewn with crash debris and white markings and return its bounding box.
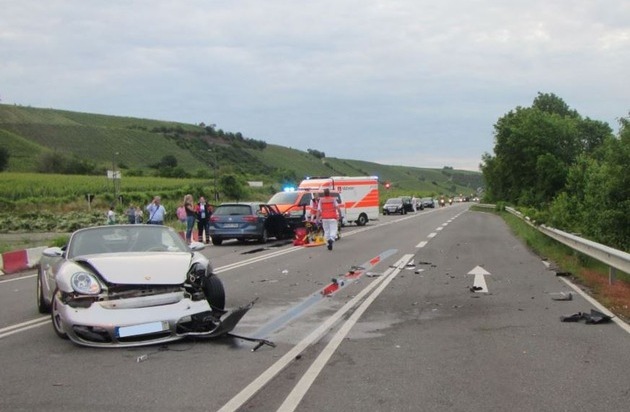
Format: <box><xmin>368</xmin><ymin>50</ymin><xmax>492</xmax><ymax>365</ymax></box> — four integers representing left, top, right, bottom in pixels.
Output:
<box><xmin>0</xmin><ymin>204</ymin><xmax>630</xmax><ymax>411</ymax></box>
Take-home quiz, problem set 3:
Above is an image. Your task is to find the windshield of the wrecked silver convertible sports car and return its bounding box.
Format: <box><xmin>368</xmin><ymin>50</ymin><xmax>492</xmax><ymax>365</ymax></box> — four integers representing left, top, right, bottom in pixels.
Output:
<box><xmin>67</xmin><ymin>225</ymin><xmax>190</xmax><ymax>258</ymax></box>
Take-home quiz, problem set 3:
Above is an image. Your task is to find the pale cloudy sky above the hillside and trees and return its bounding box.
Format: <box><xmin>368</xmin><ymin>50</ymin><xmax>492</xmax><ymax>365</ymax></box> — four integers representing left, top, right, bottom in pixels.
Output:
<box><xmin>0</xmin><ymin>0</ymin><xmax>630</xmax><ymax>170</ymax></box>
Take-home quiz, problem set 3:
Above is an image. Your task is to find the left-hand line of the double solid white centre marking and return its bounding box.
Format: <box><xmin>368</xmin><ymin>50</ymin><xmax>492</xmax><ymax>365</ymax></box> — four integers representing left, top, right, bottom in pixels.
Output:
<box><xmin>218</xmin><ymin>254</ymin><xmax>414</xmax><ymax>412</ymax></box>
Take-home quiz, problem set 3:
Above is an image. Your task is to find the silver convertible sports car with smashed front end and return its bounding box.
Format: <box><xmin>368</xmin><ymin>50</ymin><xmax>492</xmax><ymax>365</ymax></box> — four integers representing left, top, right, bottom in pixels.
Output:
<box><xmin>37</xmin><ymin>225</ymin><xmax>249</xmax><ymax>347</ymax></box>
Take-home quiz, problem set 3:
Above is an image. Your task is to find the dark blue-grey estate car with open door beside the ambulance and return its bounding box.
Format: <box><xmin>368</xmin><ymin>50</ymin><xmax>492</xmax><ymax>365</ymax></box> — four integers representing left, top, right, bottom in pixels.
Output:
<box><xmin>210</xmin><ymin>202</ymin><xmax>293</xmax><ymax>246</ymax></box>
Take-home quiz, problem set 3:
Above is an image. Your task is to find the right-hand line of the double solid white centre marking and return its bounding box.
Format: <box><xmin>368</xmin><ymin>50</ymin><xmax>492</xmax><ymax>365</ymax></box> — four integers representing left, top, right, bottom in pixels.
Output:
<box><xmin>278</xmin><ymin>255</ymin><xmax>413</xmax><ymax>412</ymax></box>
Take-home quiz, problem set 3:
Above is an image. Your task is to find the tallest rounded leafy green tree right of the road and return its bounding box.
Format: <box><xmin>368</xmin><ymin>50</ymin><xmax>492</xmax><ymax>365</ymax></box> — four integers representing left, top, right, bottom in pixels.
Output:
<box><xmin>481</xmin><ymin>93</ymin><xmax>610</xmax><ymax>208</ymax></box>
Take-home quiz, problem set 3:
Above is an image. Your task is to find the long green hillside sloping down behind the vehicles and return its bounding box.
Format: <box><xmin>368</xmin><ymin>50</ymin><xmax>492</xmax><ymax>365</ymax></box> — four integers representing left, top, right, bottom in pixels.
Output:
<box><xmin>0</xmin><ymin>104</ymin><xmax>482</xmax><ymax>195</ymax></box>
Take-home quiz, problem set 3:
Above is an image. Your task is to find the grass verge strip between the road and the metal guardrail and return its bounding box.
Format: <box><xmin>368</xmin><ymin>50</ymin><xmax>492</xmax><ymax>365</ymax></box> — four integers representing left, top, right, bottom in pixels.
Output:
<box><xmin>472</xmin><ymin>208</ymin><xmax>630</xmax><ymax>323</ymax></box>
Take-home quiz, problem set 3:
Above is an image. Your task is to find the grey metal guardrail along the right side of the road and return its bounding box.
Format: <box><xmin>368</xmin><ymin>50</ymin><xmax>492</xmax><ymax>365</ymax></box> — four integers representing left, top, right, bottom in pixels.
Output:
<box><xmin>505</xmin><ymin>207</ymin><xmax>630</xmax><ymax>283</ymax></box>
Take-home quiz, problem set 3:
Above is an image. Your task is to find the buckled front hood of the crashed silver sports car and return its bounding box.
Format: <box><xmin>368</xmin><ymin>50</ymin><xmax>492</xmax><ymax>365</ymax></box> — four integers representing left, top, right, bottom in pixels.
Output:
<box><xmin>84</xmin><ymin>252</ymin><xmax>192</xmax><ymax>285</ymax></box>
